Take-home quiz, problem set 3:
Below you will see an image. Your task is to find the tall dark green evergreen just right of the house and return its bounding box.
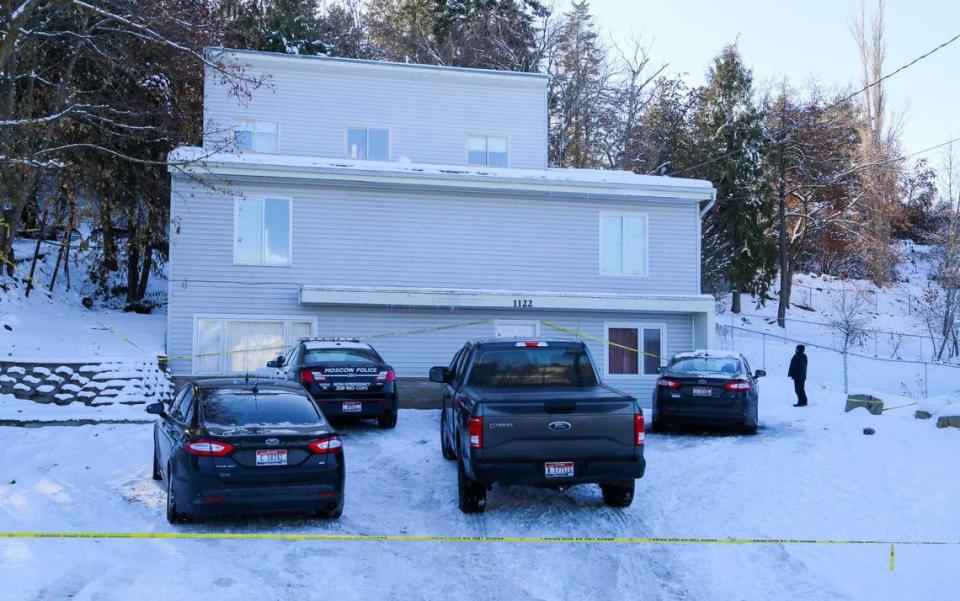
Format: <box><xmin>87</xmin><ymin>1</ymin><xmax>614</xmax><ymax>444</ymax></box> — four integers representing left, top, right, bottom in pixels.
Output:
<box><xmin>695</xmin><ymin>45</ymin><xmax>777</xmax><ymax>313</ymax></box>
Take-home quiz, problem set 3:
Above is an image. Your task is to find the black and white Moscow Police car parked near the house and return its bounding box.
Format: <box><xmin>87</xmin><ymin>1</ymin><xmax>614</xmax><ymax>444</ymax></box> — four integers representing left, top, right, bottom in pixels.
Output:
<box><xmin>267</xmin><ymin>338</ymin><xmax>399</xmax><ymax>428</ymax></box>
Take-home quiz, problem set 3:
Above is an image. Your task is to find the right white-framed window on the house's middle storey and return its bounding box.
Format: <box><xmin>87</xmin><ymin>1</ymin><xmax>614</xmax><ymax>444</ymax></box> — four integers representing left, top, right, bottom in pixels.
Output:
<box><xmin>600</xmin><ymin>213</ymin><xmax>649</xmax><ymax>276</ymax></box>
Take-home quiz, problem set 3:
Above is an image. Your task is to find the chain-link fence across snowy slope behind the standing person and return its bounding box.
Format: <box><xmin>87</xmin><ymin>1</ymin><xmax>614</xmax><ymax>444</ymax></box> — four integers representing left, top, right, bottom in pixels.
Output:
<box><xmin>717</xmin><ymin>324</ymin><xmax>960</xmax><ymax>399</ymax></box>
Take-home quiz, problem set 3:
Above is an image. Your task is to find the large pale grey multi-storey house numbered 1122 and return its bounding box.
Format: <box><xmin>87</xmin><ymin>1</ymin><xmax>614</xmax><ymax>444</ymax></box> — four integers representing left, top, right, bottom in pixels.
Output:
<box><xmin>167</xmin><ymin>51</ymin><xmax>714</xmax><ymax>402</ymax></box>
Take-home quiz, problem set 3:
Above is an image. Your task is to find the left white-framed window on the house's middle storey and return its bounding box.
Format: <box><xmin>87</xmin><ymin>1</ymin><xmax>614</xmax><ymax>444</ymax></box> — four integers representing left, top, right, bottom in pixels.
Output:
<box><xmin>234</xmin><ymin>197</ymin><xmax>291</xmax><ymax>265</ymax></box>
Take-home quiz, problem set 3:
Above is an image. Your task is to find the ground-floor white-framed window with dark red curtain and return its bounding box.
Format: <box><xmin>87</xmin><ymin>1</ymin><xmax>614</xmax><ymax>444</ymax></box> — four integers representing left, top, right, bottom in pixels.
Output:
<box><xmin>604</xmin><ymin>323</ymin><xmax>665</xmax><ymax>376</ymax></box>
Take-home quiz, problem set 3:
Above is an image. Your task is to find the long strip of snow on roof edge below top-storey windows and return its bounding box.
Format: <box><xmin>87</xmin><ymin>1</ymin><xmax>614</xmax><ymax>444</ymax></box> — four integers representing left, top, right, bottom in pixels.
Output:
<box><xmin>167</xmin><ymin>146</ymin><xmax>713</xmax><ymax>200</ymax></box>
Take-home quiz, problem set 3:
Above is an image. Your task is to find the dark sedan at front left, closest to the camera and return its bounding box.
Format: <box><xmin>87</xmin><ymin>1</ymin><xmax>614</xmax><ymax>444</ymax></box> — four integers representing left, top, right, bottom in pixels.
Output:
<box><xmin>147</xmin><ymin>378</ymin><xmax>344</xmax><ymax>523</ymax></box>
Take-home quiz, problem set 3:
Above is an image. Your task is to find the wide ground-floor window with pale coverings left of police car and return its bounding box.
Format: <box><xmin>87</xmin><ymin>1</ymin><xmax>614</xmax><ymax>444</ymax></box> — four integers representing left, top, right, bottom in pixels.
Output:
<box><xmin>194</xmin><ymin>316</ymin><xmax>314</xmax><ymax>374</ymax></box>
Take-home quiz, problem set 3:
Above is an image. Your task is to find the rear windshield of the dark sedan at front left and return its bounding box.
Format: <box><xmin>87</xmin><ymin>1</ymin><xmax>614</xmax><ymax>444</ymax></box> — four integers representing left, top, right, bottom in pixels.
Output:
<box><xmin>203</xmin><ymin>390</ymin><xmax>323</xmax><ymax>426</ymax></box>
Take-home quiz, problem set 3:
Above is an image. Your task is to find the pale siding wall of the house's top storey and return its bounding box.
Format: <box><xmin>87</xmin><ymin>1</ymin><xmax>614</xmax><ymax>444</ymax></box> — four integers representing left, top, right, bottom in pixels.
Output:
<box><xmin>204</xmin><ymin>53</ymin><xmax>547</xmax><ymax>169</ymax></box>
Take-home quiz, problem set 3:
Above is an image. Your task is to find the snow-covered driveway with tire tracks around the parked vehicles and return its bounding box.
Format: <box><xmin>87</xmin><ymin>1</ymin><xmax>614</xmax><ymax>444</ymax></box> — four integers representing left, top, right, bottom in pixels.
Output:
<box><xmin>0</xmin><ymin>382</ymin><xmax>960</xmax><ymax>600</ymax></box>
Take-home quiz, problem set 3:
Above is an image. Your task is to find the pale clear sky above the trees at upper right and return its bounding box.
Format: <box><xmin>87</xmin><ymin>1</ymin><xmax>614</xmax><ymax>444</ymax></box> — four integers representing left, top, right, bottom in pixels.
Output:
<box><xmin>591</xmin><ymin>0</ymin><xmax>960</xmax><ymax>165</ymax></box>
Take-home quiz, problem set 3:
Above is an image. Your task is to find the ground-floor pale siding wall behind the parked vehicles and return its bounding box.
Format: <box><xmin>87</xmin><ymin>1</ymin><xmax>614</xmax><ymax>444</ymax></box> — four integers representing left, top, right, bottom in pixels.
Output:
<box><xmin>168</xmin><ymin>283</ymin><xmax>694</xmax><ymax>406</ymax></box>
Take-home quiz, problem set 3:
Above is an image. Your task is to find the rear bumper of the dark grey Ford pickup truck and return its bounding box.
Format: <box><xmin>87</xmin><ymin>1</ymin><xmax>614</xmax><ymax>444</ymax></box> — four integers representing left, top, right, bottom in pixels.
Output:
<box><xmin>464</xmin><ymin>457</ymin><xmax>647</xmax><ymax>486</ymax></box>
